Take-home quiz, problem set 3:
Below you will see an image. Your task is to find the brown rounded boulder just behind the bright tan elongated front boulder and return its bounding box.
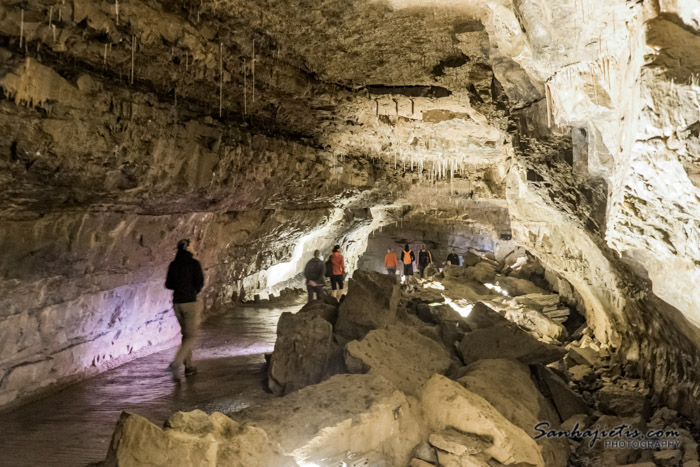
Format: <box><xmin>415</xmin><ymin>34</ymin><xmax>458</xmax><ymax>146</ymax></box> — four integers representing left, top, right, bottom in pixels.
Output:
<box><xmin>457</xmin><ymin>359</ymin><xmax>569</xmax><ymax>467</ymax></box>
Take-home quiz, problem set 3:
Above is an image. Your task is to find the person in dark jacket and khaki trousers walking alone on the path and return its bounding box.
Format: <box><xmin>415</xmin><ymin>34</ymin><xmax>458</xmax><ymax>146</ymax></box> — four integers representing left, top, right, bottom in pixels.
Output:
<box><xmin>165</xmin><ymin>239</ymin><xmax>204</xmax><ymax>381</ymax></box>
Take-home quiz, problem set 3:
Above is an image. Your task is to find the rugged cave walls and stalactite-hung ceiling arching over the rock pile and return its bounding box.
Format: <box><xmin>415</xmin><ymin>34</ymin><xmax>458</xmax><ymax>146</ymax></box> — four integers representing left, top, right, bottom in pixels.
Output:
<box><xmin>0</xmin><ymin>0</ymin><xmax>700</xmax><ymax>424</ymax></box>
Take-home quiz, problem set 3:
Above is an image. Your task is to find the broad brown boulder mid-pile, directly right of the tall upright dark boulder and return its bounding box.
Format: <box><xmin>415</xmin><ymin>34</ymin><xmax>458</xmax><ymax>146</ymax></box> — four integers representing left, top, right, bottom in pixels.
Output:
<box><xmin>345</xmin><ymin>325</ymin><xmax>450</xmax><ymax>395</ymax></box>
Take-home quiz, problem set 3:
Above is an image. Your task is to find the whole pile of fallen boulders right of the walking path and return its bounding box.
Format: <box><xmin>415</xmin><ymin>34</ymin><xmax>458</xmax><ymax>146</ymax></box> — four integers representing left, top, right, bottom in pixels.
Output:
<box><xmin>104</xmin><ymin>261</ymin><xmax>697</xmax><ymax>467</ymax></box>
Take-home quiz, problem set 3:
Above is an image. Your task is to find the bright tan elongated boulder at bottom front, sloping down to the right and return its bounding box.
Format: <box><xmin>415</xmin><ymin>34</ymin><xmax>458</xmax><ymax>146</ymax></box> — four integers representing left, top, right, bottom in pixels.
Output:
<box><xmin>421</xmin><ymin>375</ymin><xmax>545</xmax><ymax>466</ymax></box>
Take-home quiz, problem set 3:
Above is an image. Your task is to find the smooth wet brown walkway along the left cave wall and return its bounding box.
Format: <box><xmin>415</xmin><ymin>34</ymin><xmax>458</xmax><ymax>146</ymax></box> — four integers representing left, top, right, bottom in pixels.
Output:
<box><xmin>0</xmin><ymin>306</ymin><xmax>292</xmax><ymax>467</ymax></box>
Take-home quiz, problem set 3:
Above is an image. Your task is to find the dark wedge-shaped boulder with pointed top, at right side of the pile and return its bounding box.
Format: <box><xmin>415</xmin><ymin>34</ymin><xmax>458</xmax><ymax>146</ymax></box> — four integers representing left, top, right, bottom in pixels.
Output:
<box><xmin>459</xmin><ymin>303</ymin><xmax>566</xmax><ymax>364</ymax></box>
